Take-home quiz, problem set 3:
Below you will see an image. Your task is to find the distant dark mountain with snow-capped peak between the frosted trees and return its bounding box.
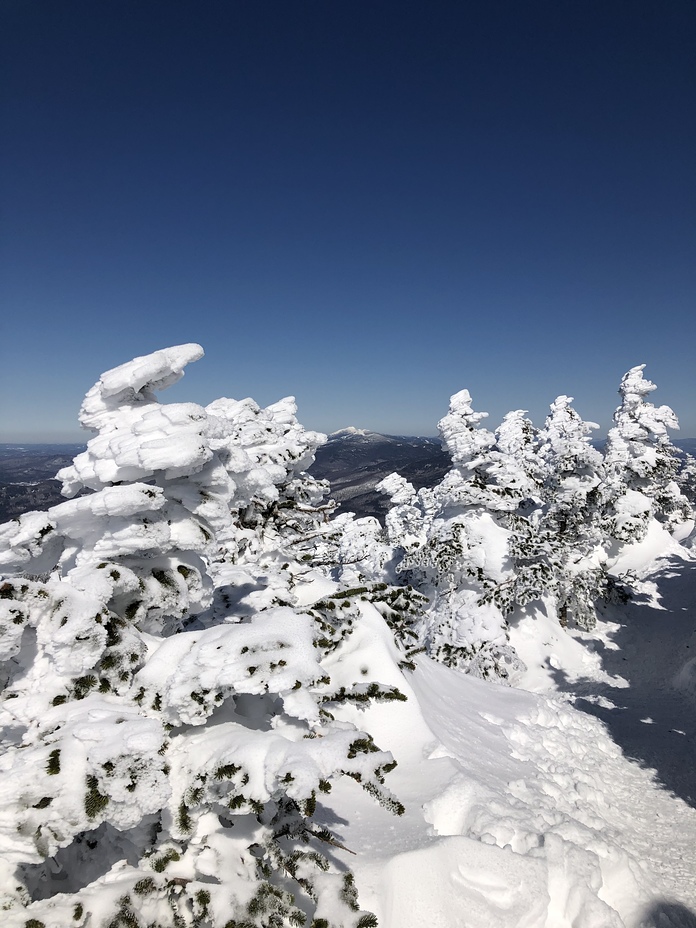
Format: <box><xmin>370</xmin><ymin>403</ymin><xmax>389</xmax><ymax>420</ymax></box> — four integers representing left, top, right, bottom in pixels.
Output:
<box><xmin>310</xmin><ymin>428</ymin><xmax>452</xmax><ymax>519</ymax></box>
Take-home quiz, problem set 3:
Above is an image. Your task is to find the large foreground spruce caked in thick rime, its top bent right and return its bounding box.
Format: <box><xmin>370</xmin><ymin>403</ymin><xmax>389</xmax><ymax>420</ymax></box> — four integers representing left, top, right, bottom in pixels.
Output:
<box><xmin>0</xmin><ymin>345</ymin><xmax>404</xmax><ymax>928</ymax></box>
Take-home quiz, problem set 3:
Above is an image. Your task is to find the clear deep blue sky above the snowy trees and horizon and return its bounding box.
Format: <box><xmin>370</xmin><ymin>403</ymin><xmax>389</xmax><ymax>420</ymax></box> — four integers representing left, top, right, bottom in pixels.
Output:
<box><xmin>0</xmin><ymin>0</ymin><xmax>696</xmax><ymax>441</ymax></box>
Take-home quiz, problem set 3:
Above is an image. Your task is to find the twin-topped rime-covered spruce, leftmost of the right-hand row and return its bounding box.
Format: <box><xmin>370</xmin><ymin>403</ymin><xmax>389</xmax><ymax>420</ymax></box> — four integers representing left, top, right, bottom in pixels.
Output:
<box><xmin>368</xmin><ymin>390</ymin><xmax>532</xmax><ymax>678</ymax></box>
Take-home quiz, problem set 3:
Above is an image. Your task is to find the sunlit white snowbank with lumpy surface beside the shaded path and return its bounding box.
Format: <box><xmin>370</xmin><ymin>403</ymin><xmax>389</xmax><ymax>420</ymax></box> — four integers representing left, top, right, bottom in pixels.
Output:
<box><xmin>324</xmin><ymin>580</ymin><xmax>696</xmax><ymax>928</ymax></box>
